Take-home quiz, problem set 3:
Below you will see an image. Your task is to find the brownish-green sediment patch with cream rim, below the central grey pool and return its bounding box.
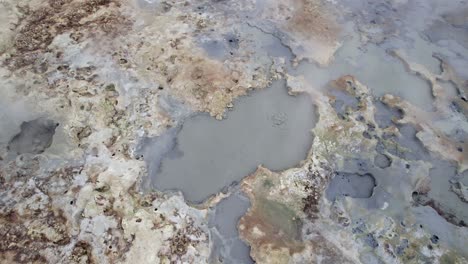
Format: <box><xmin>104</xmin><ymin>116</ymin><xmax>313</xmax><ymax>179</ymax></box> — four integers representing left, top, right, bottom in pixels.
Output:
<box><xmin>238</xmin><ymin>166</ymin><xmax>351</xmax><ymax>263</ymax></box>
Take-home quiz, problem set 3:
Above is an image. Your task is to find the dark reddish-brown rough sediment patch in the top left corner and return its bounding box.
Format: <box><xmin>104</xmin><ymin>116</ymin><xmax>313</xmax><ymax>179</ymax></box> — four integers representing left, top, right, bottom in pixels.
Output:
<box><xmin>7</xmin><ymin>0</ymin><xmax>128</xmax><ymax>68</ymax></box>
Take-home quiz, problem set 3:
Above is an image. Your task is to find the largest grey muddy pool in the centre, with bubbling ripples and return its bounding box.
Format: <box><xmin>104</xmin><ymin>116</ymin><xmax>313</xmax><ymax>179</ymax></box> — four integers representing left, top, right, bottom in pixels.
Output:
<box><xmin>143</xmin><ymin>81</ymin><xmax>316</xmax><ymax>203</ymax></box>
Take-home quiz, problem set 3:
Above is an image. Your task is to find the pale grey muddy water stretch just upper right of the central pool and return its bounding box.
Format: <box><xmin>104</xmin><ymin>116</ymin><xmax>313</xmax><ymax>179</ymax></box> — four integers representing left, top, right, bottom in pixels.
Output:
<box><xmin>293</xmin><ymin>34</ymin><xmax>433</xmax><ymax>110</ymax></box>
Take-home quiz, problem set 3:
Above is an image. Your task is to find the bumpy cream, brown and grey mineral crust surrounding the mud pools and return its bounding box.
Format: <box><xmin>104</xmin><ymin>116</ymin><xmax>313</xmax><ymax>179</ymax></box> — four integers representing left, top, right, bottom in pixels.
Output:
<box><xmin>0</xmin><ymin>0</ymin><xmax>468</xmax><ymax>263</ymax></box>
